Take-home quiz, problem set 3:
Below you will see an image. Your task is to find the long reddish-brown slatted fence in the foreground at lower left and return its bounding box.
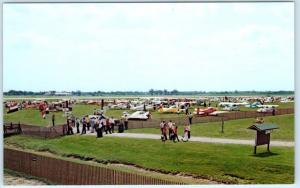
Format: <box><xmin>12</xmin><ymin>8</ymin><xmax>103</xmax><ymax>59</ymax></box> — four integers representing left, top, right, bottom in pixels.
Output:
<box><xmin>4</xmin><ymin>148</ymin><xmax>182</xmax><ymax>185</ymax></box>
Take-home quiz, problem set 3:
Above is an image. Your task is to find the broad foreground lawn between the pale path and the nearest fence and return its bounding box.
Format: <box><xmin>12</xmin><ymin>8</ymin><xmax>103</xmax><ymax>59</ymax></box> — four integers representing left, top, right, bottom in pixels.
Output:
<box><xmin>4</xmin><ymin>135</ymin><xmax>294</xmax><ymax>183</ymax></box>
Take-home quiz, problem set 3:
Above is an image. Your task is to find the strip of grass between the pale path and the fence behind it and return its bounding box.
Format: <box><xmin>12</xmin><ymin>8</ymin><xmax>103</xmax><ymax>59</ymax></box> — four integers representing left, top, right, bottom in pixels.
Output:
<box><xmin>127</xmin><ymin>114</ymin><xmax>294</xmax><ymax>141</ymax></box>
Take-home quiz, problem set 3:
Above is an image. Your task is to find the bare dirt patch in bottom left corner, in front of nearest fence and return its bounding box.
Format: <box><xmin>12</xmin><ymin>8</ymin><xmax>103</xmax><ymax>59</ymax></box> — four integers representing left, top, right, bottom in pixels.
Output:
<box><xmin>3</xmin><ymin>173</ymin><xmax>47</xmax><ymax>185</ymax></box>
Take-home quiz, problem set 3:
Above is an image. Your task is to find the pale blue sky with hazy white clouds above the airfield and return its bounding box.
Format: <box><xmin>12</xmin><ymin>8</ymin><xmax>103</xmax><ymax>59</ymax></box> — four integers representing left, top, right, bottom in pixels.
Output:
<box><xmin>3</xmin><ymin>3</ymin><xmax>294</xmax><ymax>91</ymax></box>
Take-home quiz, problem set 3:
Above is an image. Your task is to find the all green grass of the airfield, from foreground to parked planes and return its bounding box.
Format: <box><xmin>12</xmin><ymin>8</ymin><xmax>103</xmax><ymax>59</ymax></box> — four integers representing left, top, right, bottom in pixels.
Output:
<box><xmin>4</xmin><ymin>97</ymin><xmax>294</xmax><ymax>184</ymax></box>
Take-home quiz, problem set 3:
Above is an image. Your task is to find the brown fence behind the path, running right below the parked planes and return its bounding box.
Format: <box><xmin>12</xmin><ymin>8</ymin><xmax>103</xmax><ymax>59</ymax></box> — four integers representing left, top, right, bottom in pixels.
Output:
<box><xmin>128</xmin><ymin>108</ymin><xmax>294</xmax><ymax>129</ymax></box>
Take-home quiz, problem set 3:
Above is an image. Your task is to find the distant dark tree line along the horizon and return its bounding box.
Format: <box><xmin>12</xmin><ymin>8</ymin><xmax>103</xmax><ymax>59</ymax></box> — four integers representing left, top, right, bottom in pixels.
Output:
<box><xmin>3</xmin><ymin>89</ymin><xmax>294</xmax><ymax>96</ymax></box>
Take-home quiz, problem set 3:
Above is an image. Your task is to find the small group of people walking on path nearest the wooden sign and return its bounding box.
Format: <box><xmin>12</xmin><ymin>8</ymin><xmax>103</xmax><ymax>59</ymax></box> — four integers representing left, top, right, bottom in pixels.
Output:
<box><xmin>160</xmin><ymin>120</ymin><xmax>191</xmax><ymax>143</ymax></box>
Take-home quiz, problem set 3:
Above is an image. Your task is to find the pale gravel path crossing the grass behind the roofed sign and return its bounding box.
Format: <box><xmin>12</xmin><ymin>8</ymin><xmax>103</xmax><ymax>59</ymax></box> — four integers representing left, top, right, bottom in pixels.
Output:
<box><xmin>74</xmin><ymin>129</ymin><xmax>295</xmax><ymax>147</ymax></box>
